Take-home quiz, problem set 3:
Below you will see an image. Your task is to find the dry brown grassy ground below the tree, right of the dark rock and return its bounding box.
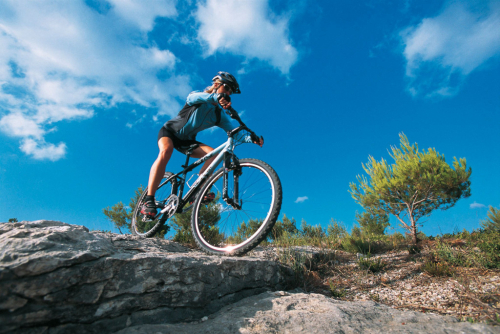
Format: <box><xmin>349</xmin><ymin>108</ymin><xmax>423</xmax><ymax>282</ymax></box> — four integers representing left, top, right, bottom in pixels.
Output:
<box><xmin>268</xmin><ymin>242</ymin><xmax>500</xmax><ymax>325</ymax></box>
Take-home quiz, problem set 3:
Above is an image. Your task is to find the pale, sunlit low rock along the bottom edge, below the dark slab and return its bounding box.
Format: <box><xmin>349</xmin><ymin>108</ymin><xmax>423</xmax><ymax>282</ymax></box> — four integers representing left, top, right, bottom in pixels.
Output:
<box><xmin>117</xmin><ymin>292</ymin><xmax>500</xmax><ymax>334</ymax></box>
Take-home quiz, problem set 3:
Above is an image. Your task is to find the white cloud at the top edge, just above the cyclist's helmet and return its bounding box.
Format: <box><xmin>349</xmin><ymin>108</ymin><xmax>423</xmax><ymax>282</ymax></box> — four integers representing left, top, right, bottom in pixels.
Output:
<box><xmin>195</xmin><ymin>0</ymin><xmax>298</xmax><ymax>74</ymax></box>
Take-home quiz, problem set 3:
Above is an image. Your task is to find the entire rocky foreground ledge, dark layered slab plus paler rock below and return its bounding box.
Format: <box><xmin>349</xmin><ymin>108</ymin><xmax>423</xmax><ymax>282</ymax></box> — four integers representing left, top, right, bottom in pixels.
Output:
<box><xmin>0</xmin><ymin>221</ymin><xmax>500</xmax><ymax>334</ymax></box>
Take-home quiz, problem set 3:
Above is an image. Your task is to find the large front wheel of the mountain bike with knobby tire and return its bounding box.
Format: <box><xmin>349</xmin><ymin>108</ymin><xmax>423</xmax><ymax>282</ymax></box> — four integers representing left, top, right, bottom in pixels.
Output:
<box><xmin>191</xmin><ymin>159</ymin><xmax>283</xmax><ymax>256</ymax></box>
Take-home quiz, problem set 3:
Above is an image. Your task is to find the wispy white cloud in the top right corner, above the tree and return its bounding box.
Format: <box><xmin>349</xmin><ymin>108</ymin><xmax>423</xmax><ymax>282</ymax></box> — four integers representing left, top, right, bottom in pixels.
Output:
<box><xmin>400</xmin><ymin>1</ymin><xmax>500</xmax><ymax>96</ymax></box>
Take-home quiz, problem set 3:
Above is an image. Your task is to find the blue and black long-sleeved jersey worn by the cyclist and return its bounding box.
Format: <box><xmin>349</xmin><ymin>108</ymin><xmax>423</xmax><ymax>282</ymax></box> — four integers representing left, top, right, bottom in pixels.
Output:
<box><xmin>164</xmin><ymin>92</ymin><xmax>252</xmax><ymax>143</ymax></box>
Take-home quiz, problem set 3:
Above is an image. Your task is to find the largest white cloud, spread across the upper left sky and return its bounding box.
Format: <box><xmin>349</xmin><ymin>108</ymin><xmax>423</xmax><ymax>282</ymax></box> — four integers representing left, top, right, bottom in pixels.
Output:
<box><xmin>0</xmin><ymin>0</ymin><xmax>191</xmax><ymax>160</ymax></box>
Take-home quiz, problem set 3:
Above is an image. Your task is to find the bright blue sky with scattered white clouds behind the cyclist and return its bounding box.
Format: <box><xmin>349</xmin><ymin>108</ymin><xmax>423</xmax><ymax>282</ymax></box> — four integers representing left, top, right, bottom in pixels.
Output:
<box><xmin>0</xmin><ymin>0</ymin><xmax>500</xmax><ymax>235</ymax></box>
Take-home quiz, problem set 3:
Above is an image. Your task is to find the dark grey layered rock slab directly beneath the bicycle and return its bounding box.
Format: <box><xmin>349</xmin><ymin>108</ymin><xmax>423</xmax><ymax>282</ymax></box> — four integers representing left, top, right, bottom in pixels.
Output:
<box><xmin>0</xmin><ymin>221</ymin><xmax>291</xmax><ymax>333</ymax></box>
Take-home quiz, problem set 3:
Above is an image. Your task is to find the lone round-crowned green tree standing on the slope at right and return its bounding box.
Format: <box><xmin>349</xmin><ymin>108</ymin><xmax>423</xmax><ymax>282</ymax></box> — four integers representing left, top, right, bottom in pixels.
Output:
<box><xmin>350</xmin><ymin>134</ymin><xmax>472</xmax><ymax>244</ymax></box>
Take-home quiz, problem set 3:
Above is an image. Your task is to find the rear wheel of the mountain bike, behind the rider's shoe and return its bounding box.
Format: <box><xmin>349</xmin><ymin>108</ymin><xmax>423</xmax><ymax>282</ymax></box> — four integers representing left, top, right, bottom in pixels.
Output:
<box><xmin>130</xmin><ymin>172</ymin><xmax>176</xmax><ymax>238</ymax></box>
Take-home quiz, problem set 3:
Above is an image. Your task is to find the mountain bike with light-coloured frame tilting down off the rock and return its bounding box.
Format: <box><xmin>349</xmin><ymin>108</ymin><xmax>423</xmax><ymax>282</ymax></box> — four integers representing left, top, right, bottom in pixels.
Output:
<box><xmin>131</xmin><ymin>108</ymin><xmax>282</xmax><ymax>255</ymax></box>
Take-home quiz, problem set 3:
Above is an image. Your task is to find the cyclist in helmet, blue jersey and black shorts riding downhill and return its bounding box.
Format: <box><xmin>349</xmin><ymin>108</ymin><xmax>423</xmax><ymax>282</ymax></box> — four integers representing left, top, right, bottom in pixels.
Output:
<box><xmin>141</xmin><ymin>72</ymin><xmax>264</xmax><ymax>218</ymax></box>
